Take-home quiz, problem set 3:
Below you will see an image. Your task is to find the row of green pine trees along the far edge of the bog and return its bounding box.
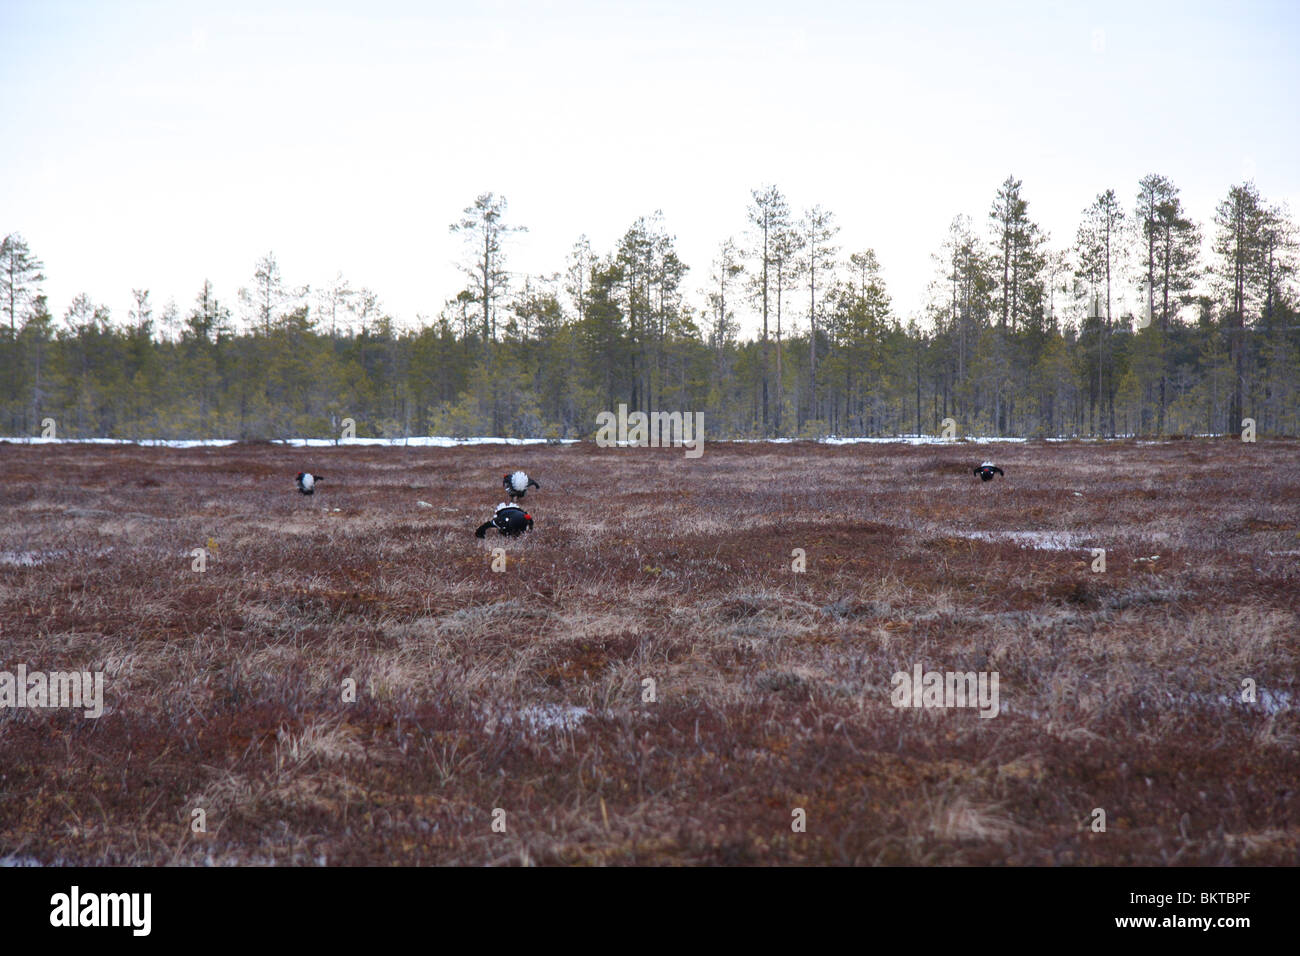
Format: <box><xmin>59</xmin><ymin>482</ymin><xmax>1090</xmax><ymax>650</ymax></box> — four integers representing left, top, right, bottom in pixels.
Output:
<box><xmin>0</xmin><ymin>174</ymin><xmax>1300</xmax><ymax>440</ymax></box>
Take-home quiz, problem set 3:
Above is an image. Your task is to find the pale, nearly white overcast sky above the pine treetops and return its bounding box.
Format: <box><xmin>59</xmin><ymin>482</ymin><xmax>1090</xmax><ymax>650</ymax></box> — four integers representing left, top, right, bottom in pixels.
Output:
<box><xmin>0</xmin><ymin>0</ymin><xmax>1300</xmax><ymax>332</ymax></box>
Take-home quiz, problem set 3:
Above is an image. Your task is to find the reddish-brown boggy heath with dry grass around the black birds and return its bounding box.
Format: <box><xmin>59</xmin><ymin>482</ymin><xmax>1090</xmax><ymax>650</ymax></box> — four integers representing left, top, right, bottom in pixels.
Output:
<box><xmin>0</xmin><ymin>440</ymin><xmax>1300</xmax><ymax>865</ymax></box>
